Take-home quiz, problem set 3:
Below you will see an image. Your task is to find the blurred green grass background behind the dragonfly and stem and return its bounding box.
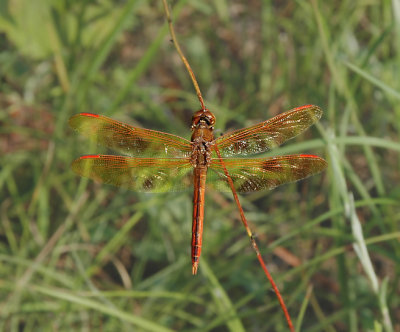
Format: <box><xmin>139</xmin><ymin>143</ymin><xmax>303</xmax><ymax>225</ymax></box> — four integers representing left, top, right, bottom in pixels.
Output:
<box><xmin>0</xmin><ymin>0</ymin><xmax>400</xmax><ymax>332</ymax></box>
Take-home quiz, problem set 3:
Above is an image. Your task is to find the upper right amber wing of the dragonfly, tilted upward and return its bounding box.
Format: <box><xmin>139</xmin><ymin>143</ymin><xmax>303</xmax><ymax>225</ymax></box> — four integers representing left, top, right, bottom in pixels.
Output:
<box><xmin>215</xmin><ymin>105</ymin><xmax>322</xmax><ymax>157</ymax></box>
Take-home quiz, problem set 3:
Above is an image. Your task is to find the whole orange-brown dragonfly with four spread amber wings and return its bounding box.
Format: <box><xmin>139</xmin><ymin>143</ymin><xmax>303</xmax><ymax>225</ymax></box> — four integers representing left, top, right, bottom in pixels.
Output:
<box><xmin>69</xmin><ymin>105</ymin><xmax>327</xmax><ymax>274</ymax></box>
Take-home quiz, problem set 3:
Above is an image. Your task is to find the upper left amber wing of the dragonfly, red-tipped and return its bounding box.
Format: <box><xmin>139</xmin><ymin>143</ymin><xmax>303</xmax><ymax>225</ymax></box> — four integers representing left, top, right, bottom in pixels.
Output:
<box><xmin>69</xmin><ymin>113</ymin><xmax>191</xmax><ymax>157</ymax></box>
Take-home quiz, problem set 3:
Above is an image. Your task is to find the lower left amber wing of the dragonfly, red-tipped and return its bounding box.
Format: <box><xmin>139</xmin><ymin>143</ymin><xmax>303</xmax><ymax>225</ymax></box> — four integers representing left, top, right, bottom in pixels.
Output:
<box><xmin>71</xmin><ymin>155</ymin><xmax>193</xmax><ymax>192</ymax></box>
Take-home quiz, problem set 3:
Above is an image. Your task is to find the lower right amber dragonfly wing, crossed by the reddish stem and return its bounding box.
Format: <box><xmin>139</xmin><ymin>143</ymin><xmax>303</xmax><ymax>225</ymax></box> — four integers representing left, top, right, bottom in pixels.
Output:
<box><xmin>207</xmin><ymin>155</ymin><xmax>327</xmax><ymax>192</ymax></box>
